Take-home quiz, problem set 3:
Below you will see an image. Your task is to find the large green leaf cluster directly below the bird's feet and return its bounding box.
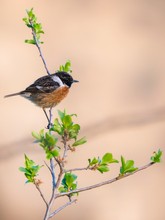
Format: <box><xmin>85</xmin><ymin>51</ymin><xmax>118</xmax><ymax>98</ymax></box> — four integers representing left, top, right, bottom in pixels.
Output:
<box><xmin>32</xmin><ymin>110</ymin><xmax>86</xmax><ymax>159</ymax></box>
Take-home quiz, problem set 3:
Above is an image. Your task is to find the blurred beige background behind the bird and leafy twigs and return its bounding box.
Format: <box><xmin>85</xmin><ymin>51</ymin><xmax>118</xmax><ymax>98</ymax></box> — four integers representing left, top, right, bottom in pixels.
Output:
<box><xmin>0</xmin><ymin>0</ymin><xmax>165</xmax><ymax>220</ymax></box>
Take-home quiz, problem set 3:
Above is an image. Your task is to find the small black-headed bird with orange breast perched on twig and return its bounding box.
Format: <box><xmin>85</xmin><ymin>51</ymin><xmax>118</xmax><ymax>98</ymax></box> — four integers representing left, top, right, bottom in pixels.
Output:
<box><xmin>5</xmin><ymin>71</ymin><xmax>79</xmax><ymax>128</ymax></box>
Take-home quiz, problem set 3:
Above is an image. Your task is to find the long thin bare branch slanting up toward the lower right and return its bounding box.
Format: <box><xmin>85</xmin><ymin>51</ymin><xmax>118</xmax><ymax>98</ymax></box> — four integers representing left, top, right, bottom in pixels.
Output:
<box><xmin>56</xmin><ymin>162</ymin><xmax>155</xmax><ymax>198</ymax></box>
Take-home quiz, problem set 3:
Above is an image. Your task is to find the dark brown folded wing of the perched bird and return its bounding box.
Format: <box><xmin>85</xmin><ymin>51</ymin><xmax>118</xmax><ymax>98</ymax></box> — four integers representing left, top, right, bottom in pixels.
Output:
<box><xmin>21</xmin><ymin>76</ymin><xmax>60</xmax><ymax>94</ymax></box>
